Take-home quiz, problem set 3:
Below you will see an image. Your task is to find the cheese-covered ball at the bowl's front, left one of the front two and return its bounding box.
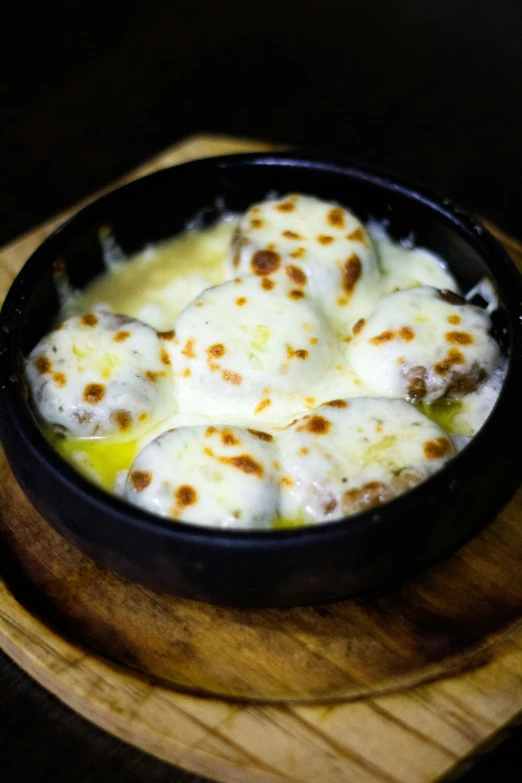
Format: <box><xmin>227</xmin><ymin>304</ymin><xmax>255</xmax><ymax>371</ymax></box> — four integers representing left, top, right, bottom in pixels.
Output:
<box><xmin>125</xmin><ymin>426</ymin><xmax>279</xmax><ymax>528</ymax></box>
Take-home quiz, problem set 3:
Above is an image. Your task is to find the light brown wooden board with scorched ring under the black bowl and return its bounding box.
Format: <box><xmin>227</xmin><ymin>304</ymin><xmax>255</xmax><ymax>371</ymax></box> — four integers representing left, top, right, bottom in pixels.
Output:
<box><xmin>0</xmin><ymin>137</ymin><xmax>522</xmax><ymax>783</ymax></box>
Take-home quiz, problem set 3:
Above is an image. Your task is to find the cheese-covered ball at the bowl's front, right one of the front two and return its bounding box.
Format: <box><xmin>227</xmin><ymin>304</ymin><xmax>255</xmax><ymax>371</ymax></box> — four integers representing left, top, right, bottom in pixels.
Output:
<box><xmin>278</xmin><ymin>397</ymin><xmax>455</xmax><ymax>523</ymax></box>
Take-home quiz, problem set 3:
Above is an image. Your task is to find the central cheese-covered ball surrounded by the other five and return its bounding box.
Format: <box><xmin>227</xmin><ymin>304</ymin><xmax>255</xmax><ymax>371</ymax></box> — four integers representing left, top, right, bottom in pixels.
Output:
<box><xmin>171</xmin><ymin>275</ymin><xmax>330</xmax><ymax>417</ymax></box>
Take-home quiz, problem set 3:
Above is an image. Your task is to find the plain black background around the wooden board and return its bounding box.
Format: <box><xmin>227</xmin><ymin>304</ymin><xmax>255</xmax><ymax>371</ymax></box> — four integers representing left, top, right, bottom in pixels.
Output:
<box><xmin>0</xmin><ymin>0</ymin><xmax>522</xmax><ymax>783</ymax></box>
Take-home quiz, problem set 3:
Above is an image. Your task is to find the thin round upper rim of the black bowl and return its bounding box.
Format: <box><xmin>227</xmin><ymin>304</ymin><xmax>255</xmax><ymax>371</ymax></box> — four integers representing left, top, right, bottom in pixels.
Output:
<box><xmin>0</xmin><ymin>150</ymin><xmax>522</xmax><ymax>548</ymax></box>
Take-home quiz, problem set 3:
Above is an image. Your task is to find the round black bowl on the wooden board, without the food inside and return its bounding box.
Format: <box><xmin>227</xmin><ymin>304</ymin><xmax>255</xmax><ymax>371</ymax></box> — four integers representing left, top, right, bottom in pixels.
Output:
<box><xmin>0</xmin><ymin>154</ymin><xmax>522</xmax><ymax>606</ymax></box>
